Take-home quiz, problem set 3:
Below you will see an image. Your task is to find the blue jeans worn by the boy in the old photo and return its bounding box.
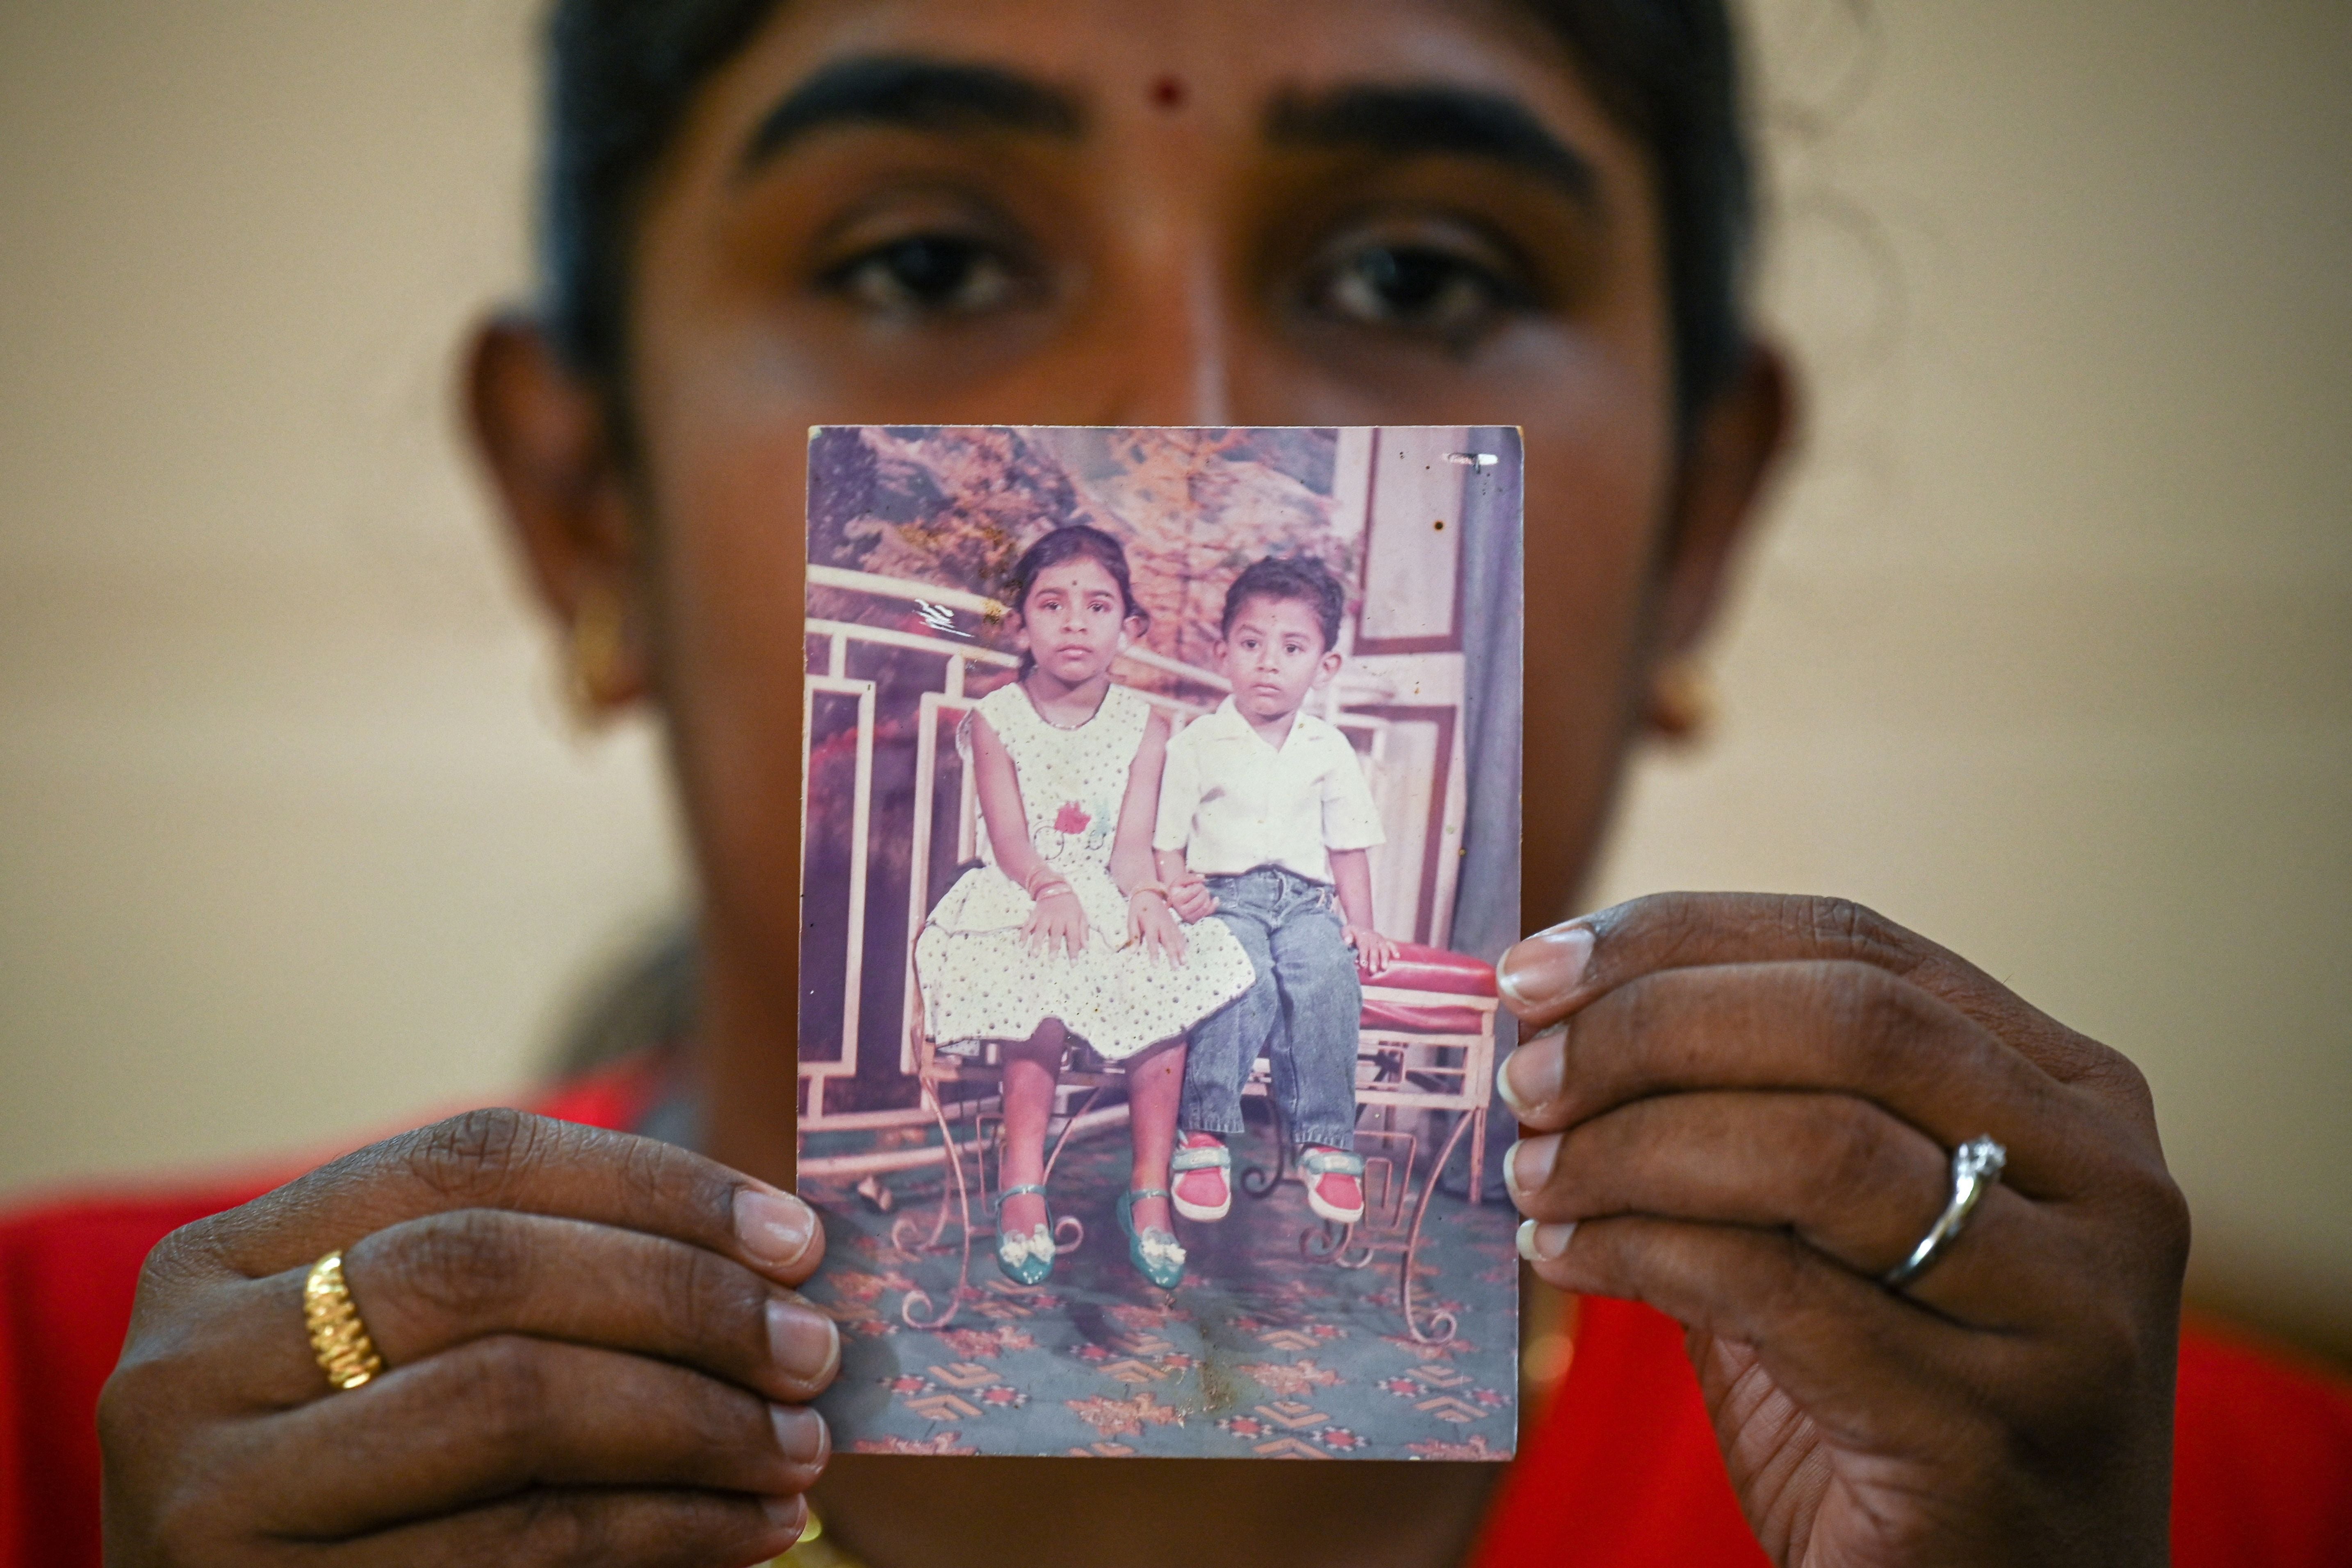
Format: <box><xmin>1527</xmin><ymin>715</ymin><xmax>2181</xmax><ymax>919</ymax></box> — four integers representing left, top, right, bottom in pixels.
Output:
<box><xmin>1181</xmin><ymin>865</ymin><xmax>1364</xmax><ymax>1150</ymax></box>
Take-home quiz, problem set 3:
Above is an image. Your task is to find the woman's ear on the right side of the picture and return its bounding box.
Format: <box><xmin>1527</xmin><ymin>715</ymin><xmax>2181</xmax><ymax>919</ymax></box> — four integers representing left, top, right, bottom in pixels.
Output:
<box><xmin>1649</xmin><ymin>343</ymin><xmax>1797</xmax><ymax>677</ymax></box>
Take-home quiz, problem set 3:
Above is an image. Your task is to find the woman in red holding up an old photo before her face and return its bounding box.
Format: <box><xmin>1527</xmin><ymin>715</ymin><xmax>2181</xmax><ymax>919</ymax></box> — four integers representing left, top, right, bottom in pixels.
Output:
<box><xmin>0</xmin><ymin>0</ymin><xmax>2352</xmax><ymax>1568</ymax></box>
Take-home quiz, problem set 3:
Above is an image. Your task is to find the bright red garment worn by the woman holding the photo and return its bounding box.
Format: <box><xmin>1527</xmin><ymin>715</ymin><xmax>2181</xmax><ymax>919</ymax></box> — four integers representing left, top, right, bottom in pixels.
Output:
<box><xmin>0</xmin><ymin>1070</ymin><xmax>2352</xmax><ymax>1568</ymax></box>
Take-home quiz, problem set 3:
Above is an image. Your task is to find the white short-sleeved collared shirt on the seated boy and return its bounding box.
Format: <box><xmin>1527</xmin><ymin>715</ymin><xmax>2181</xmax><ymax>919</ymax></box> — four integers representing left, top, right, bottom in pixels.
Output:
<box><xmin>1153</xmin><ymin>696</ymin><xmax>1388</xmax><ymax>882</ymax></box>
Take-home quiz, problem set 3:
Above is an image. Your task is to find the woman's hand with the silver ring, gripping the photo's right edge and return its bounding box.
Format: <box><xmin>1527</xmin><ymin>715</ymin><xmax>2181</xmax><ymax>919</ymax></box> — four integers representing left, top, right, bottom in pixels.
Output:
<box><xmin>1503</xmin><ymin>893</ymin><xmax>2190</xmax><ymax>1563</ymax></box>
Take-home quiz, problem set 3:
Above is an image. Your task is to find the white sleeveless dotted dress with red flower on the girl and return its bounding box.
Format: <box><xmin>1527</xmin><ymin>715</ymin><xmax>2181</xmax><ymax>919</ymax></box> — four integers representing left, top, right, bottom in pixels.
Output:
<box><xmin>915</xmin><ymin>682</ymin><xmax>1256</xmax><ymax>1060</ymax></box>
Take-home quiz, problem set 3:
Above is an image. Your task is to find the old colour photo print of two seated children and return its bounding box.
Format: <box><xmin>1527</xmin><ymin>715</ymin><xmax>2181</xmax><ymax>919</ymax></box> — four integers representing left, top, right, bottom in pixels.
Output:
<box><xmin>800</xmin><ymin>426</ymin><xmax>1522</xmax><ymax>1460</ymax></box>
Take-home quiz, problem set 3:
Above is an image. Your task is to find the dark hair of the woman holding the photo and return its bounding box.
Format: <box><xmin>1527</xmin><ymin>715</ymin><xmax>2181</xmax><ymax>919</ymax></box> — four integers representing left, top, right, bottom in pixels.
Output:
<box><xmin>541</xmin><ymin>0</ymin><xmax>1755</xmax><ymax>430</ymax></box>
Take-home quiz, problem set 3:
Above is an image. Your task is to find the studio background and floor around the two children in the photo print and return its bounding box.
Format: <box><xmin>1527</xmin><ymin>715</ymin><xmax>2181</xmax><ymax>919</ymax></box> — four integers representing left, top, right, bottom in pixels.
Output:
<box><xmin>800</xmin><ymin>428</ymin><xmax>1522</xmax><ymax>1460</ymax></box>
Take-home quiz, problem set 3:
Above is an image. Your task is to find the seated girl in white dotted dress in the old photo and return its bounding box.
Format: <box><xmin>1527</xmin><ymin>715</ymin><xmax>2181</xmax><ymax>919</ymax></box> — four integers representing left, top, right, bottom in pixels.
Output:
<box><xmin>915</xmin><ymin>526</ymin><xmax>1256</xmax><ymax>1288</ymax></box>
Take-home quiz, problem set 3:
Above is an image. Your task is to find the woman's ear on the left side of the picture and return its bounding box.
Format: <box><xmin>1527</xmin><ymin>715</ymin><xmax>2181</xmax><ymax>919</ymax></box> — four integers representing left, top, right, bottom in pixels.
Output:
<box><xmin>466</xmin><ymin>315</ymin><xmax>652</xmax><ymax>717</ymax></box>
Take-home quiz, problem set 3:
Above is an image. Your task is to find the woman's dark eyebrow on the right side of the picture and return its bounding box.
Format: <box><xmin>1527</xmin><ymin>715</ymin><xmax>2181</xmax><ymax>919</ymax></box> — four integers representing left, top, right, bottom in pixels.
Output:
<box><xmin>1265</xmin><ymin>82</ymin><xmax>1599</xmax><ymax>207</ymax></box>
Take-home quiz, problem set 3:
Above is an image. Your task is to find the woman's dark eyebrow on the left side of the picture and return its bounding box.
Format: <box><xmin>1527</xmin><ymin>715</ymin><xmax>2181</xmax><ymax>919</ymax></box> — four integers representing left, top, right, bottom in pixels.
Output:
<box><xmin>738</xmin><ymin>54</ymin><xmax>1084</xmax><ymax>174</ymax></box>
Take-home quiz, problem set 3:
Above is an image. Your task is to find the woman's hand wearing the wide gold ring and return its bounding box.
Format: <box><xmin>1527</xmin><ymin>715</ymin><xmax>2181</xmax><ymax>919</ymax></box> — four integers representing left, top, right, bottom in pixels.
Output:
<box><xmin>99</xmin><ymin>1110</ymin><xmax>840</xmax><ymax>1568</ymax></box>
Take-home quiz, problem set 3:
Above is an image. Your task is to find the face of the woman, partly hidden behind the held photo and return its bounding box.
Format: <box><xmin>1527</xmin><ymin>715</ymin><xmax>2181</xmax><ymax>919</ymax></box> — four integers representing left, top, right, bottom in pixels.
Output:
<box><xmin>477</xmin><ymin>0</ymin><xmax>1778</xmax><ymax>1081</ymax></box>
